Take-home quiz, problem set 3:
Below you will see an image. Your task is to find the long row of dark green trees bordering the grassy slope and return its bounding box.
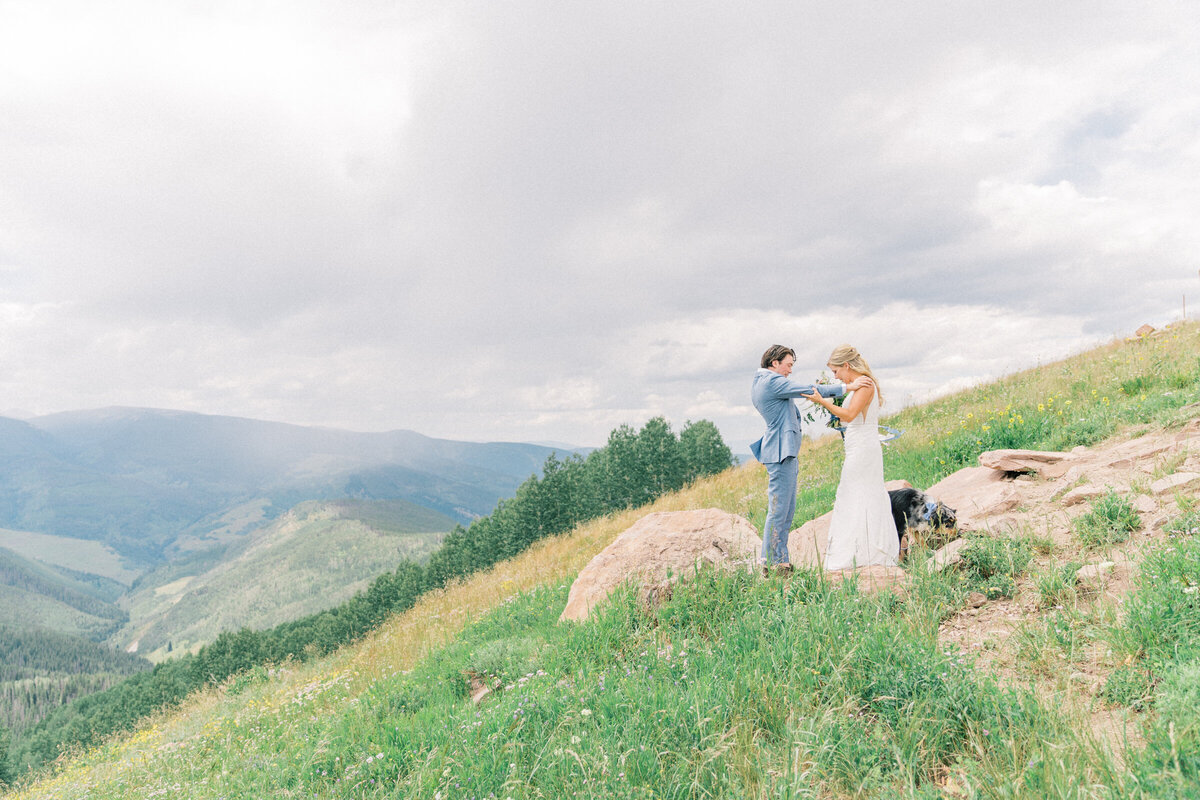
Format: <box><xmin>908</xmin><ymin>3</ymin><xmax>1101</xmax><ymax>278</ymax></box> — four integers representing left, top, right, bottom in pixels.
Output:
<box><xmin>7</xmin><ymin>417</ymin><xmax>733</xmax><ymax>769</ymax></box>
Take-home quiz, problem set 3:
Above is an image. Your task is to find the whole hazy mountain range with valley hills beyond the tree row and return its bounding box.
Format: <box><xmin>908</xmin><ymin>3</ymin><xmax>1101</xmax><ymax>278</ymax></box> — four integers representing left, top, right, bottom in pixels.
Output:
<box><xmin>0</xmin><ymin>408</ymin><xmax>580</xmax><ymax>681</ymax></box>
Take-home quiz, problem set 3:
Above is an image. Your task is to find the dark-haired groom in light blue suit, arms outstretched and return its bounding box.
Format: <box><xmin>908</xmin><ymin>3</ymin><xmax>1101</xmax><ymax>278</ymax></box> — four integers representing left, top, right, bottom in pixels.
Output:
<box><xmin>750</xmin><ymin>344</ymin><xmax>868</xmax><ymax>575</ymax></box>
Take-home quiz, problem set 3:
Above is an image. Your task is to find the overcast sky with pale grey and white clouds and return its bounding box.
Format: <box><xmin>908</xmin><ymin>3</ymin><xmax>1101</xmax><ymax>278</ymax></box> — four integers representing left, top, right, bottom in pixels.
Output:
<box><xmin>0</xmin><ymin>0</ymin><xmax>1200</xmax><ymax>452</ymax></box>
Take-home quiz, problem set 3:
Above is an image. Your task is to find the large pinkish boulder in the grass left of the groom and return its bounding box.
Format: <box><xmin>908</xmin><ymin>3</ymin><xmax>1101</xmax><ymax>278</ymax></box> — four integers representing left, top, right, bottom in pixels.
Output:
<box><xmin>559</xmin><ymin>509</ymin><xmax>762</xmax><ymax>621</ymax></box>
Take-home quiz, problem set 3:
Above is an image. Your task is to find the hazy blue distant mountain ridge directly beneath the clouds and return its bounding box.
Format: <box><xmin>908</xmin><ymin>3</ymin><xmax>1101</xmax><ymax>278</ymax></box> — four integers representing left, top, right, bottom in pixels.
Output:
<box><xmin>0</xmin><ymin>408</ymin><xmax>564</xmax><ymax>566</ymax></box>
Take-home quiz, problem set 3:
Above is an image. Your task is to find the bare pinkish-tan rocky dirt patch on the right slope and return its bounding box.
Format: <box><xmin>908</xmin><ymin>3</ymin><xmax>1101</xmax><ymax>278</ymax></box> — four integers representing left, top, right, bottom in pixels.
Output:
<box><xmin>931</xmin><ymin>420</ymin><xmax>1200</xmax><ymax>759</ymax></box>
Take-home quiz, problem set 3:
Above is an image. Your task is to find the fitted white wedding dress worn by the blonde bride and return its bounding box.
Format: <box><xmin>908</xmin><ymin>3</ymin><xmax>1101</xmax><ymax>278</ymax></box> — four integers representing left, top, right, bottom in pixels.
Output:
<box><xmin>824</xmin><ymin>393</ymin><xmax>900</xmax><ymax>570</ymax></box>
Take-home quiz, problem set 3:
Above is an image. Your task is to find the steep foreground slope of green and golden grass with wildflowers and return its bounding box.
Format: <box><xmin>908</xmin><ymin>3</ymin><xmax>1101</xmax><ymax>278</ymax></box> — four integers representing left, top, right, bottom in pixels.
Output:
<box><xmin>13</xmin><ymin>325</ymin><xmax>1200</xmax><ymax>800</ymax></box>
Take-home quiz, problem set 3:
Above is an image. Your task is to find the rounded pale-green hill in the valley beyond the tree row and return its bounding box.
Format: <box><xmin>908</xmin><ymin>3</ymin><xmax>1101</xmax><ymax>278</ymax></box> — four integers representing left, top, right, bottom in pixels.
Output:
<box><xmin>114</xmin><ymin>500</ymin><xmax>455</xmax><ymax>661</ymax></box>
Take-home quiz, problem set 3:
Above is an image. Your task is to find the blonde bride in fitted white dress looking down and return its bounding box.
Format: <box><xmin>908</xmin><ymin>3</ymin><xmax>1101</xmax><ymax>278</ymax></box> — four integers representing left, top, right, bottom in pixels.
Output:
<box><xmin>805</xmin><ymin>344</ymin><xmax>900</xmax><ymax>571</ymax></box>
